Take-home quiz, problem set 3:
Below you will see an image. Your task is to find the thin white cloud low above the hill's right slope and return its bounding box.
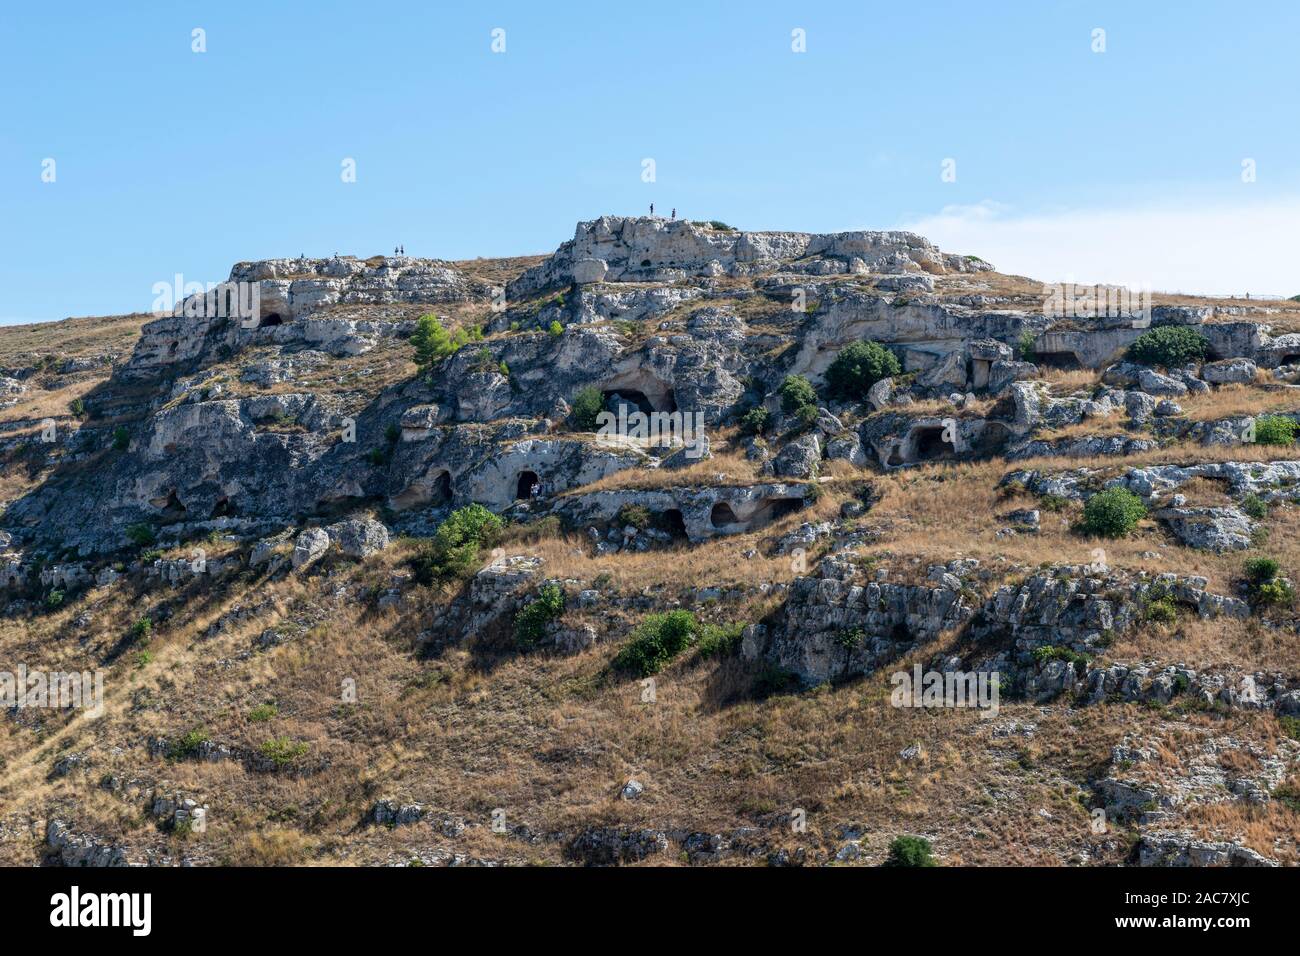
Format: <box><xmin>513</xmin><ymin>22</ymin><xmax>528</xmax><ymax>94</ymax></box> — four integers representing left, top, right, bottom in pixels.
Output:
<box><xmin>901</xmin><ymin>196</ymin><xmax>1300</xmax><ymax>295</ymax></box>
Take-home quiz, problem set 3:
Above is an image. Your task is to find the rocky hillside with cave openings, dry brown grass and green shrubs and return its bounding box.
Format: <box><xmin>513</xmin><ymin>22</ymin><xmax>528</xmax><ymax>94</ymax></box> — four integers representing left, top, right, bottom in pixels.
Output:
<box><xmin>0</xmin><ymin>217</ymin><xmax>1300</xmax><ymax>865</ymax></box>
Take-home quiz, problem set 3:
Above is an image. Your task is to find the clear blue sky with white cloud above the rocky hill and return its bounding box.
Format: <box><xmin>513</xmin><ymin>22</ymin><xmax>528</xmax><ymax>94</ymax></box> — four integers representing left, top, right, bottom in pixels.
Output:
<box><xmin>0</xmin><ymin>0</ymin><xmax>1300</xmax><ymax>323</ymax></box>
